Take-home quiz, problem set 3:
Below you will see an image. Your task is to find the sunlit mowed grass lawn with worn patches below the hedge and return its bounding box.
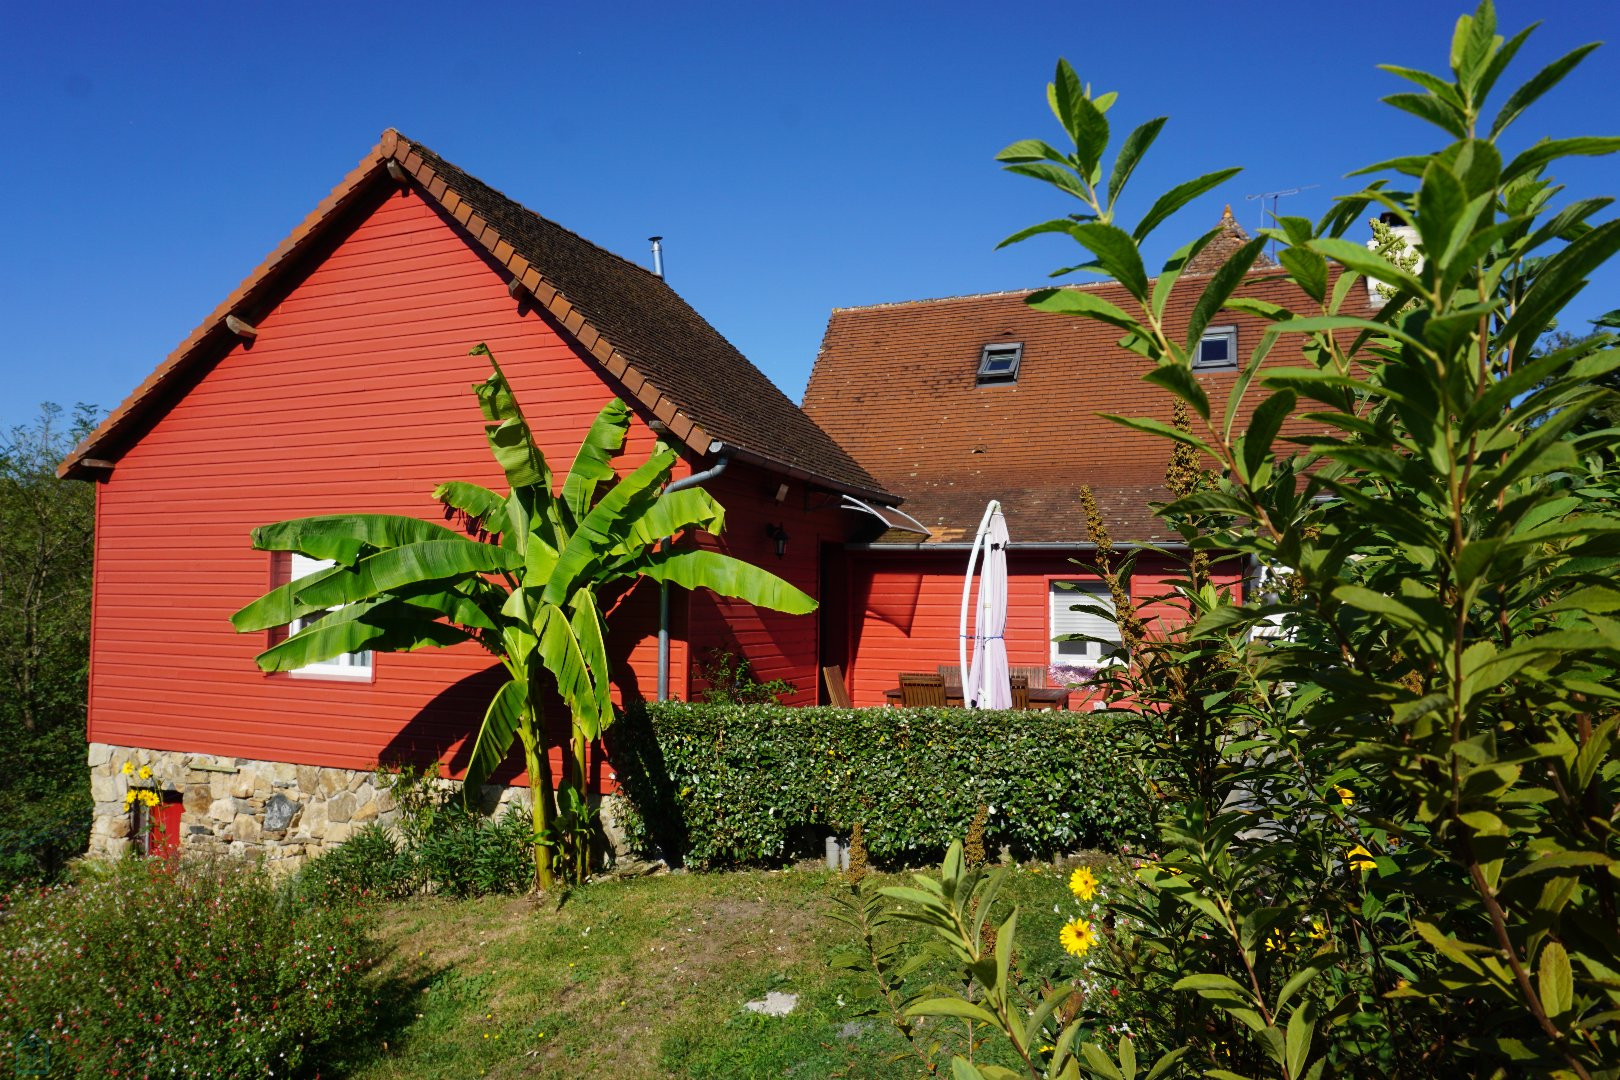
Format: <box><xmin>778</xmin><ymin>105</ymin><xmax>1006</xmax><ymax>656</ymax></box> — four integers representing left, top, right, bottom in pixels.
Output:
<box><xmin>348</xmin><ymin>866</ymin><xmax>1095</xmax><ymax>1080</ymax></box>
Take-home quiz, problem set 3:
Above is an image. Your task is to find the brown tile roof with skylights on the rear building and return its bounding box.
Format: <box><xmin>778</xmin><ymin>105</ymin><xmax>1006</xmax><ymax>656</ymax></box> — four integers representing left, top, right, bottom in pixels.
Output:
<box><xmin>804</xmin><ymin>230</ymin><xmax>1360</xmax><ymax>544</ymax></box>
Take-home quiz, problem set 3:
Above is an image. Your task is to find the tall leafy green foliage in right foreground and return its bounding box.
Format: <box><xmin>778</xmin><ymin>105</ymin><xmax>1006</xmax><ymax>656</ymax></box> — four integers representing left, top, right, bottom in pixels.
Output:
<box><xmin>868</xmin><ymin>0</ymin><xmax>1620</xmax><ymax>1080</ymax></box>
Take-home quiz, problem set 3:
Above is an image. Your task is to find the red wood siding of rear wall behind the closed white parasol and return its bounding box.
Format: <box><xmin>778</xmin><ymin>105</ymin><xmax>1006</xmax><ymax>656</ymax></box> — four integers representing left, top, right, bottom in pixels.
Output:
<box><xmin>829</xmin><ymin>551</ymin><xmax>1234</xmax><ymax>708</ymax></box>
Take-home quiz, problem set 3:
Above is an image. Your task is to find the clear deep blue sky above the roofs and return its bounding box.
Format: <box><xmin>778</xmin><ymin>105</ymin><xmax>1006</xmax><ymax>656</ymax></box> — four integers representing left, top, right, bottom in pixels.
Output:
<box><xmin>0</xmin><ymin>0</ymin><xmax>1620</xmax><ymax>427</ymax></box>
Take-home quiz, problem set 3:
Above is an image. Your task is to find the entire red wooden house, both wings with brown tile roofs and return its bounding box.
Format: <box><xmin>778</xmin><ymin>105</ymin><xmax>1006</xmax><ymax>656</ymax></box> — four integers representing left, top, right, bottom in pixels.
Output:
<box><xmin>72</xmin><ymin>131</ymin><xmax>1367</xmax><ymax>860</ymax></box>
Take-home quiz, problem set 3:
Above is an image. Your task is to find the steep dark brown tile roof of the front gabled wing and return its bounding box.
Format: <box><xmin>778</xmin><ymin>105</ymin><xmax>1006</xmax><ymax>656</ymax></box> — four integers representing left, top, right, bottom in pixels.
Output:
<box><xmin>60</xmin><ymin>130</ymin><xmax>893</xmax><ymax>500</ymax></box>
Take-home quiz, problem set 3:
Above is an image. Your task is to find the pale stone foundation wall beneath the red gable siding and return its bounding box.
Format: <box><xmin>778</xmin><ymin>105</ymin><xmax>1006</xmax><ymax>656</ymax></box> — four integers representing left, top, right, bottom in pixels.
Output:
<box><xmin>89</xmin><ymin>743</ymin><xmax>620</xmax><ymax>870</ymax></box>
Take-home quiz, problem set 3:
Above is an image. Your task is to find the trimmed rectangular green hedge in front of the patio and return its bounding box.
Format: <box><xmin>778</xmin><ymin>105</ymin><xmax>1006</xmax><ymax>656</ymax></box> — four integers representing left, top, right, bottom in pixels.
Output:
<box><xmin>608</xmin><ymin>701</ymin><xmax>1149</xmax><ymax>866</ymax></box>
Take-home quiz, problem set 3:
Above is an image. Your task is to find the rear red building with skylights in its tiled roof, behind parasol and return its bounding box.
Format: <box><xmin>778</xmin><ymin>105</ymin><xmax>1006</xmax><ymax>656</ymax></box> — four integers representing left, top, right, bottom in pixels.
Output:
<box><xmin>804</xmin><ymin>207</ymin><xmax>1360</xmax><ymax>708</ymax></box>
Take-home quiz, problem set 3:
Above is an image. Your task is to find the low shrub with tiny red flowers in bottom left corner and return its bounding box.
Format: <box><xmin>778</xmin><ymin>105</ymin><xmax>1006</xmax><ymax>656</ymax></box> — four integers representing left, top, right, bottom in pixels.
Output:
<box><xmin>0</xmin><ymin>860</ymin><xmax>373</xmax><ymax>1077</ymax></box>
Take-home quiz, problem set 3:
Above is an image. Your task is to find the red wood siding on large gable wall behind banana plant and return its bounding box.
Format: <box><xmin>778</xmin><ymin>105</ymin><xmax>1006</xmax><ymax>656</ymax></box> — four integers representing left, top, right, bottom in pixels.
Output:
<box><xmin>89</xmin><ymin>194</ymin><xmax>687</xmax><ymax>790</ymax></box>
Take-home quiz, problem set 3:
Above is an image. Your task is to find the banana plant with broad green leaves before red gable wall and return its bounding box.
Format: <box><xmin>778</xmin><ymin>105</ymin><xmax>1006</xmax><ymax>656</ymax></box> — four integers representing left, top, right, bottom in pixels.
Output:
<box><xmin>232</xmin><ymin>343</ymin><xmax>816</xmax><ymax>889</ymax></box>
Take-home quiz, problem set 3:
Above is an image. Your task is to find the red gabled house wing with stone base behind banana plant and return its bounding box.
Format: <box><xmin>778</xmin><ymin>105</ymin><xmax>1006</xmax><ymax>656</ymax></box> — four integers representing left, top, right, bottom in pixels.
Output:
<box><xmin>62</xmin><ymin>131</ymin><xmax>896</xmax><ymax>857</ymax></box>
